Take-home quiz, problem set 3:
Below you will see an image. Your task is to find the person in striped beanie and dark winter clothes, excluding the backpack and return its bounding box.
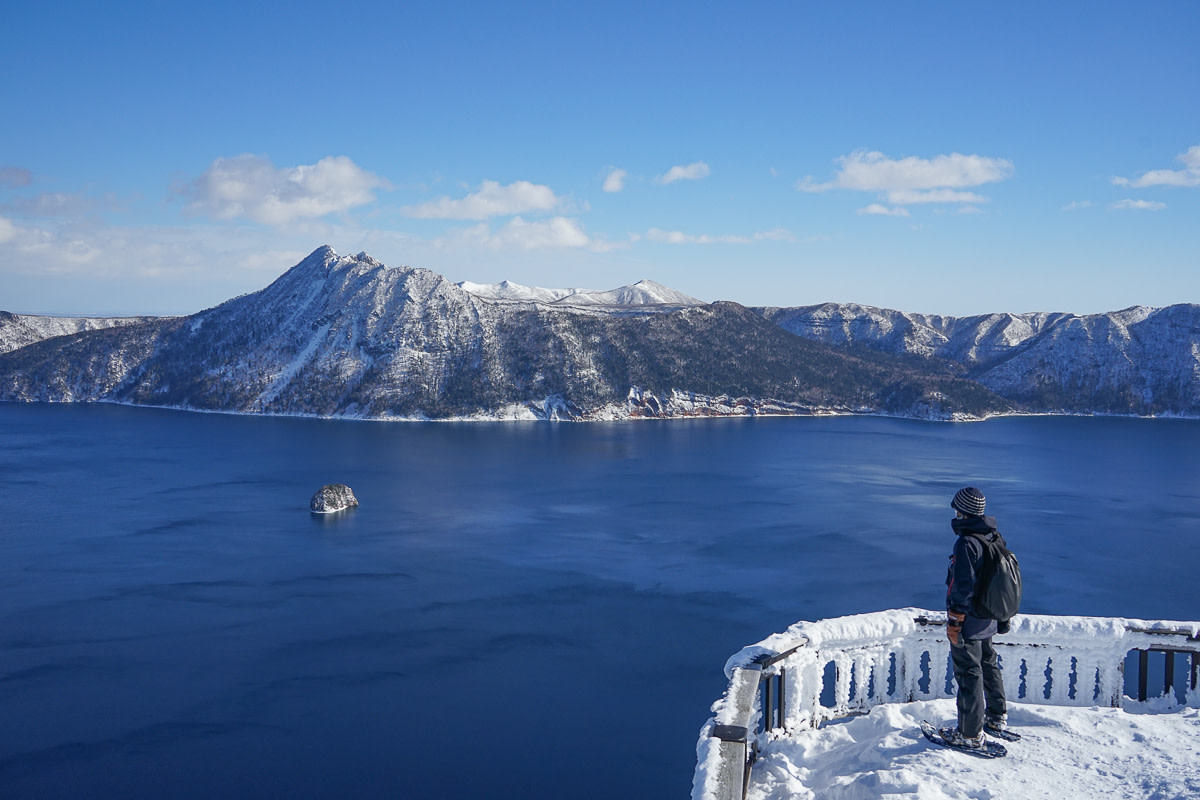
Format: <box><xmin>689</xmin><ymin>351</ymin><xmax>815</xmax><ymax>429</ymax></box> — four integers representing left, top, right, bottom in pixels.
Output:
<box><xmin>946</xmin><ymin>486</ymin><xmax>1008</xmax><ymax>747</ymax></box>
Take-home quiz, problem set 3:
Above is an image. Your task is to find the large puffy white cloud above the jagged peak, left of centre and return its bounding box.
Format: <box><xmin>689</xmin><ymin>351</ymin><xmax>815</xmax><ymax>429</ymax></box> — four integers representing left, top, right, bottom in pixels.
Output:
<box><xmin>181</xmin><ymin>155</ymin><xmax>389</xmax><ymax>227</ymax></box>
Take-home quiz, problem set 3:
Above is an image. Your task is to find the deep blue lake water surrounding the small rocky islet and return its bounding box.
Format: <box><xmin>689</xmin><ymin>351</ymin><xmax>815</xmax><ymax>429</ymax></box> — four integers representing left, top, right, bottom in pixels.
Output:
<box><xmin>0</xmin><ymin>404</ymin><xmax>1200</xmax><ymax>799</ymax></box>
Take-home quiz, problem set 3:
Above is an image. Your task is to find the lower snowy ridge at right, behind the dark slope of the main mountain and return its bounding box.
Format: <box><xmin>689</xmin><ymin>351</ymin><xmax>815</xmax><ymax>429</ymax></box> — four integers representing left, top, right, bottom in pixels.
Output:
<box><xmin>756</xmin><ymin>303</ymin><xmax>1200</xmax><ymax>415</ymax></box>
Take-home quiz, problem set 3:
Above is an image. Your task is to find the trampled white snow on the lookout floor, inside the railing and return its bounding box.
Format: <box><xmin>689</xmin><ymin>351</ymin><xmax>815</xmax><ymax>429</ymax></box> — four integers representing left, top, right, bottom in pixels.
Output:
<box><xmin>748</xmin><ymin>699</ymin><xmax>1200</xmax><ymax>800</ymax></box>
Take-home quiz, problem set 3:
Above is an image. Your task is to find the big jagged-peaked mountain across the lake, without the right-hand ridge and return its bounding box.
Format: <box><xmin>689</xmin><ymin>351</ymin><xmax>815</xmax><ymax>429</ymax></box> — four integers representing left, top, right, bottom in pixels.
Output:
<box><xmin>0</xmin><ymin>247</ymin><xmax>1010</xmax><ymax>419</ymax></box>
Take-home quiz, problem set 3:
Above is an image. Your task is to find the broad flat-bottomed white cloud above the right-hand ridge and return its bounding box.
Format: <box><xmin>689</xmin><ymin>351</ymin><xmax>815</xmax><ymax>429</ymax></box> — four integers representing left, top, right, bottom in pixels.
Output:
<box><xmin>796</xmin><ymin>150</ymin><xmax>1013</xmax><ymax>208</ymax></box>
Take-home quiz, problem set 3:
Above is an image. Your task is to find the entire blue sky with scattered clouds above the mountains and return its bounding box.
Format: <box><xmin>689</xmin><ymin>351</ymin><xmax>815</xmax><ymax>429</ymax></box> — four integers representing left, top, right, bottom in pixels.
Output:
<box><xmin>0</xmin><ymin>0</ymin><xmax>1200</xmax><ymax>315</ymax></box>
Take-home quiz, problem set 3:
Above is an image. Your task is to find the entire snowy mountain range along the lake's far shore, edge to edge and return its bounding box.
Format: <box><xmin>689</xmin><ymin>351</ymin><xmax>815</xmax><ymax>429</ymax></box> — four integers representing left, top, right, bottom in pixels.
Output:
<box><xmin>0</xmin><ymin>246</ymin><xmax>1200</xmax><ymax>420</ymax></box>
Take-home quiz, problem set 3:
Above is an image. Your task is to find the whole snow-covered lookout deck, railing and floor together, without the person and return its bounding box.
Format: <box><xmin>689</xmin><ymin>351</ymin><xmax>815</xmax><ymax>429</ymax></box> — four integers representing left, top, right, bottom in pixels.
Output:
<box><xmin>692</xmin><ymin>608</ymin><xmax>1200</xmax><ymax>800</ymax></box>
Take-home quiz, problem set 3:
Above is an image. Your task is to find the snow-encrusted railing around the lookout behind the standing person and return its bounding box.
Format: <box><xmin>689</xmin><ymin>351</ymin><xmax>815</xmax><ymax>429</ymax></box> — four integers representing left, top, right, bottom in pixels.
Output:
<box><xmin>692</xmin><ymin>608</ymin><xmax>1200</xmax><ymax>800</ymax></box>
